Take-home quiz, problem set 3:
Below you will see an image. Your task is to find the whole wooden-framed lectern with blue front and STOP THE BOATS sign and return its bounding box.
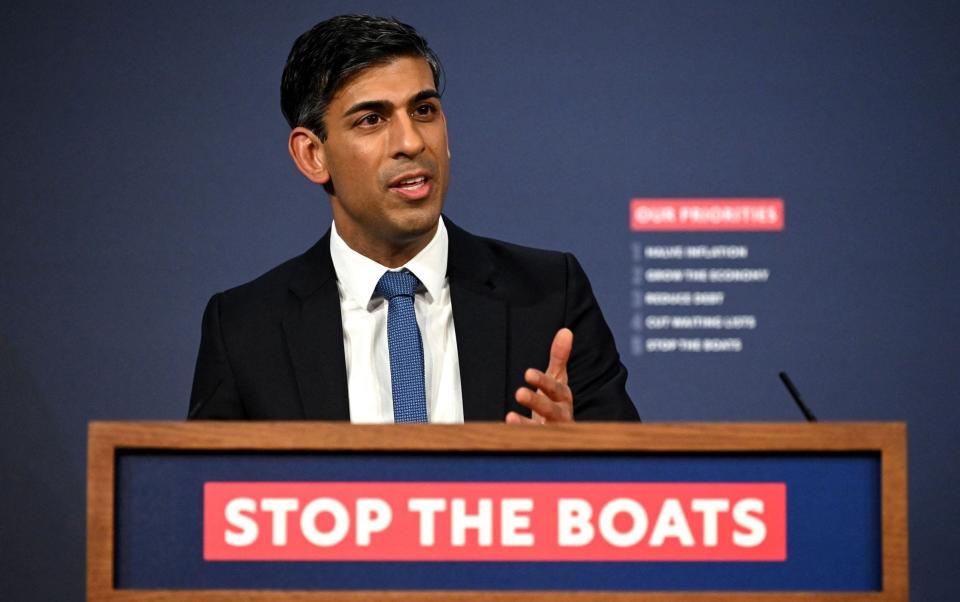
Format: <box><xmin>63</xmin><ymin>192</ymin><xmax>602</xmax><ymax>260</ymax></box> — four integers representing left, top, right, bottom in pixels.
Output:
<box><xmin>87</xmin><ymin>422</ymin><xmax>909</xmax><ymax>602</ymax></box>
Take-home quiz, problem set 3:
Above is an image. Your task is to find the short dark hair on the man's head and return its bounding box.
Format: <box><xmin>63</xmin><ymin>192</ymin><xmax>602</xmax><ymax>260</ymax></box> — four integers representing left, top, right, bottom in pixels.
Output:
<box><xmin>280</xmin><ymin>15</ymin><xmax>443</xmax><ymax>140</ymax></box>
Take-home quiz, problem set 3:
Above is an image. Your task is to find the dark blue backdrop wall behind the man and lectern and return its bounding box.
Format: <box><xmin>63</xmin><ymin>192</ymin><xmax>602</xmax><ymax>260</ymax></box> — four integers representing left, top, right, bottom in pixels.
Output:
<box><xmin>0</xmin><ymin>1</ymin><xmax>960</xmax><ymax>600</ymax></box>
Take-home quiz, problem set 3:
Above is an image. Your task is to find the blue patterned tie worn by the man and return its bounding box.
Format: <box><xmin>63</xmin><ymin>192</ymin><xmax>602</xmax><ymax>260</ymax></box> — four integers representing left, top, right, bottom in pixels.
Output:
<box><xmin>377</xmin><ymin>270</ymin><xmax>427</xmax><ymax>422</ymax></box>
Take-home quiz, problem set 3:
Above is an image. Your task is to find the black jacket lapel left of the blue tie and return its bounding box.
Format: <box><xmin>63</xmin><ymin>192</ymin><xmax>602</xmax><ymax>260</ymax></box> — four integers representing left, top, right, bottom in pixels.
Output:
<box><xmin>283</xmin><ymin>232</ymin><xmax>350</xmax><ymax>420</ymax></box>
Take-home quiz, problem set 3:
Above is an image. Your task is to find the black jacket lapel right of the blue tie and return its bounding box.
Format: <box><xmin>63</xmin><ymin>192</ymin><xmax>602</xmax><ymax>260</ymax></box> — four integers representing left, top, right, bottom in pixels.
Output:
<box><xmin>444</xmin><ymin>218</ymin><xmax>509</xmax><ymax>422</ymax></box>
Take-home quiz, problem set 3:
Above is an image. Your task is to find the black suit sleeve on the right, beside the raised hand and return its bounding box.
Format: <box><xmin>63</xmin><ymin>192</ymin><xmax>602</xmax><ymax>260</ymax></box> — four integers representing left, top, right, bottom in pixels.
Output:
<box><xmin>564</xmin><ymin>253</ymin><xmax>640</xmax><ymax>421</ymax></box>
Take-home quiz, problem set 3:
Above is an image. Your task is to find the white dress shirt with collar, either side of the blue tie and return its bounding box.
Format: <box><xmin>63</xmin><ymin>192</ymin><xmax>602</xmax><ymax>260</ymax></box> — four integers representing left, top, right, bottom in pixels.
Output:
<box><xmin>330</xmin><ymin>220</ymin><xmax>463</xmax><ymax>423</ymax></box>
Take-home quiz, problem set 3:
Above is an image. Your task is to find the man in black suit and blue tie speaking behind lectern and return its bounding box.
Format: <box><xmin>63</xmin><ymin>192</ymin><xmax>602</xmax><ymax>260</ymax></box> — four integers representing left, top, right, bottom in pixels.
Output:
<box><xmin>189</xmin><ymin>16</ymin><xmax>638</xmax><ymax>423</ymax></box>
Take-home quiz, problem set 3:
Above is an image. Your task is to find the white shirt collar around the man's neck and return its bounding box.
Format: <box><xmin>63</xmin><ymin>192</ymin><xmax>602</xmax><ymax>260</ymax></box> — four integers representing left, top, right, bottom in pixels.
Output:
<box><xmin>330</xmin><ymin>219</ymin><xmax>449</xmax><ymax>310</ymax></box>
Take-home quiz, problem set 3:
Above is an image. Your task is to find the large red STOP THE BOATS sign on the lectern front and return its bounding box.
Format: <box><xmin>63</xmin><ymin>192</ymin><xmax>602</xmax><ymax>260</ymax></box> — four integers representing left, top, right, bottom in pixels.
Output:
<box><xmin>203</xmin><ymin>482</ymin><xmax>786</xmax><ymax>561</ymax></box>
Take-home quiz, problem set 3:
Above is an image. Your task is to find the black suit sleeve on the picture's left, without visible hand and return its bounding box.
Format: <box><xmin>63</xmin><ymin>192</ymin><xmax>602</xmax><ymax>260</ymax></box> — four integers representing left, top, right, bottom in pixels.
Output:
<box><xmin>187</xmin><ymin>293</ymin><xmax>246</xmax><ymax>420</ymax></box>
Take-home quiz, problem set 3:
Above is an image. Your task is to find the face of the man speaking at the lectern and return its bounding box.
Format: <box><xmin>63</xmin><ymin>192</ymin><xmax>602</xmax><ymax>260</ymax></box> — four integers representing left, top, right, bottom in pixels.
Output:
<box><xmin>323</xmin><ymin>57</ymin><xmax>449</xmax><ymax>259</ymax></box>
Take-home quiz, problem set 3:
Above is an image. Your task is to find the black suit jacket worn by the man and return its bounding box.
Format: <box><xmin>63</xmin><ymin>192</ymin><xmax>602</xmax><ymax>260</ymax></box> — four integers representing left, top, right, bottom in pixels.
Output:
<box><xmin>189</xmin><ymin>218</ymin><xmax>639</xmax><ymax>421</ymax></box>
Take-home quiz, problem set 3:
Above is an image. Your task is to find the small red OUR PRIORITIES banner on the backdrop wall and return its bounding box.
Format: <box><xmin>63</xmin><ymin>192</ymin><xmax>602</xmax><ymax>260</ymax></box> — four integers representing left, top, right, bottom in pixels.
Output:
<box><xmin>630</xmin><ymin>199</ymin><xmax>784</xmax><ymax>232</ymax></box>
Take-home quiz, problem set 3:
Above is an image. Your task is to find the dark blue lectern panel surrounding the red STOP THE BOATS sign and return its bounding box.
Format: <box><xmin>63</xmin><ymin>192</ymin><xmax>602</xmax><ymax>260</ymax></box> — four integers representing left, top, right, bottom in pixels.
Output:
<box><xmin>115</xmin><ymin>450</ymin><xmax>882</xmax><ymax>591</ymax></box>
